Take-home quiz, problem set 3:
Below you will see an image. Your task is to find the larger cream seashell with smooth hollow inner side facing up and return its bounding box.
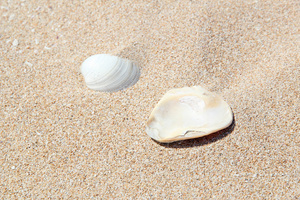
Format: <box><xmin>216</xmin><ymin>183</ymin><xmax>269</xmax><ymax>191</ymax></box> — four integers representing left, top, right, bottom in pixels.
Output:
<box><xmin>146</xmin><ymin>86</ymin><xmax>233</xmax><ymax>143</ymax></box>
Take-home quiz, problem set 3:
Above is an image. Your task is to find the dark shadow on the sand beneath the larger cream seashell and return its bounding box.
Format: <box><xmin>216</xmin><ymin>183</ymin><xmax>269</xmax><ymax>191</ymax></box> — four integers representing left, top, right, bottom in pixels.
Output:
<box><xmin>152</xmin><ymin>114</ymin><xmax>235</xmax><ymax>148</ymax></box>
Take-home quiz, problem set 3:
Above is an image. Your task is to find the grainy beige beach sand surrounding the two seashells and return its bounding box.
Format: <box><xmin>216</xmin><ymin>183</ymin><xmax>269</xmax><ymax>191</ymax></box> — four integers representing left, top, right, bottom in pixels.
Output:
<box><xmin>0</xmin><ymin>0</ymin><xmax>300</xmax><ymax>199</ymax></box>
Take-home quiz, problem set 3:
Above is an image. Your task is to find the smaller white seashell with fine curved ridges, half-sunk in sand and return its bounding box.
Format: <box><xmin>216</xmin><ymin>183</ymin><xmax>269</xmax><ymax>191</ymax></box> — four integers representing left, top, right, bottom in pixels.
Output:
<box><xmin>81</xmin><ymin>54</ymin><xmax>140</xmax><ymax>92</ymax></box>
